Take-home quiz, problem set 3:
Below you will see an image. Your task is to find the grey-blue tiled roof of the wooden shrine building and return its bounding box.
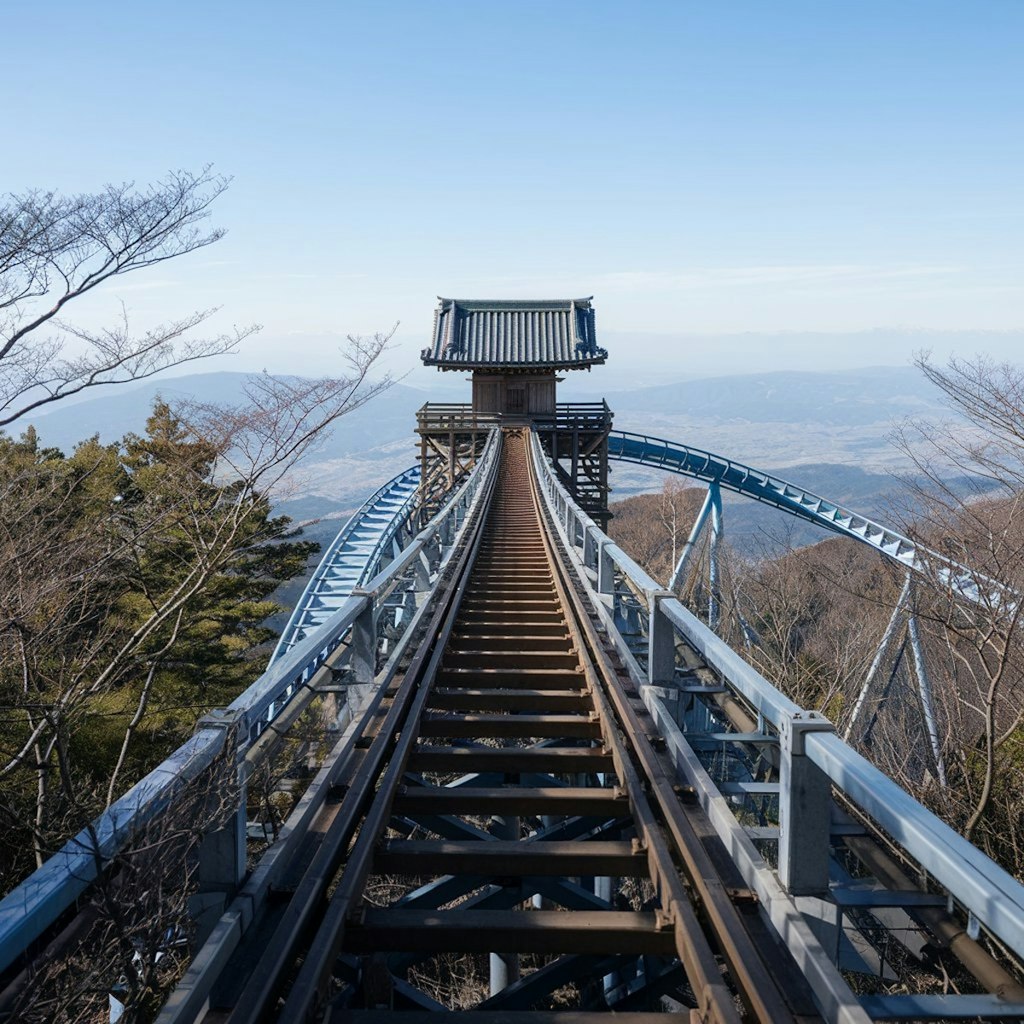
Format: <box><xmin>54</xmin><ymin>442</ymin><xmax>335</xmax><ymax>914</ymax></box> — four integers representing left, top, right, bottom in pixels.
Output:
<box><xmin>423</xmin><ymin>298</ymin><xmax>608</xmax><ymax>370</ymax></box>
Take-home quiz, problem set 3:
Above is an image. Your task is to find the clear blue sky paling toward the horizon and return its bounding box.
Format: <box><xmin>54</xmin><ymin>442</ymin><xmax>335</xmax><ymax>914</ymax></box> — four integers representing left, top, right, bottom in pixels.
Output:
<box><xmin>0</xmin><ymin>0</ymin><xmax>1024</xmax><ymax>373</ymax></box>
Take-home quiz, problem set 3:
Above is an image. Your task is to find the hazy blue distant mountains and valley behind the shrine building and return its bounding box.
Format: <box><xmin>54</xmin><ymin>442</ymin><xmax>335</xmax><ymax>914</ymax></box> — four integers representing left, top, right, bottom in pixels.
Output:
<box><xmin>19</xmin><ymin>368</ymin><xmax>945</xmax><ymax>561</ymax></box>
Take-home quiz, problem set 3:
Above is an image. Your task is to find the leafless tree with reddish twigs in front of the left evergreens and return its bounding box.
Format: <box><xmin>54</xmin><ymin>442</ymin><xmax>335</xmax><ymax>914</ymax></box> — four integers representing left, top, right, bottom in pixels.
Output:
<box><xmin>0</xmin><ymin>334</ymin><xmax>390</xmax><ymax>897</ymax></box>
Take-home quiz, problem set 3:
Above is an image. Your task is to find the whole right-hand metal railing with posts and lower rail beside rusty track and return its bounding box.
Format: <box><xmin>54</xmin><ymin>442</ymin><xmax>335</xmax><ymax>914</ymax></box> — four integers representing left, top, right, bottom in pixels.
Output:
<box><xmin>532</xmin><ymin>435</ymin><xmax>1024</xmax><ymax>1022</ymax></box>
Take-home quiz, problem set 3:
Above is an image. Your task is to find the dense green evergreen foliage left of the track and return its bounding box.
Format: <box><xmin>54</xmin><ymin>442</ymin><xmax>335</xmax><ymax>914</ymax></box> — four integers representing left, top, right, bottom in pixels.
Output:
<box><xmin>0</xmin><ymin>402</ymin><xmax>317</xmax><ymax>888</ymax></box>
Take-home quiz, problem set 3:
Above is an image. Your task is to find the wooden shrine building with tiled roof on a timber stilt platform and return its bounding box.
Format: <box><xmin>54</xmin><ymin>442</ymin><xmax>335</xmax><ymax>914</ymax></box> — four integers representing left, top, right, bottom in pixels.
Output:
<box><xmin>417</xmin><ymin>298</ymin><xmax>611</xmax><ymax>526</ymax></box>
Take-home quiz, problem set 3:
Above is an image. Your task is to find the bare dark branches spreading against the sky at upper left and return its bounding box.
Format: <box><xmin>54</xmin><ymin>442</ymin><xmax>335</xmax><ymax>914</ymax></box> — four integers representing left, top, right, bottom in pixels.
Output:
<box><xmin>0</xmin><ymin>168</ymin><xmax>256</xmax><ymax>427</ymax></box>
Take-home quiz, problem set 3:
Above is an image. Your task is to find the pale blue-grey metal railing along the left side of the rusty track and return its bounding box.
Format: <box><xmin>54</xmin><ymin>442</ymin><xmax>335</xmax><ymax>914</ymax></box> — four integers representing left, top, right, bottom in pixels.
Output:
<box><xmin>0</xmin><ymin>436</ymin><xmax>499</xmax><ymax>971</ymax></box>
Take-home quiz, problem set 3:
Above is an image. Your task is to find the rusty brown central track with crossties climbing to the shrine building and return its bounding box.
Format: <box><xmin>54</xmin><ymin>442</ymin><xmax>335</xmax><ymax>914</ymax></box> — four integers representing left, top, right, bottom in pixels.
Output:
<box><xmin>172</xmin><ymin>432</ymin><xmax>823</xmax><ymax>1024</ymax></box>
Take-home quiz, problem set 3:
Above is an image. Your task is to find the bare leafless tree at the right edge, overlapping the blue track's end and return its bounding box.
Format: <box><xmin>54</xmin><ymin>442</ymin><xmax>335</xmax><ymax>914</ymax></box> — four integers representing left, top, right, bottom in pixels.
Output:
<box><xmin>897</xmin><ymin>356</ymin><xmax>1024</xmax><ymax>851</ymax></box>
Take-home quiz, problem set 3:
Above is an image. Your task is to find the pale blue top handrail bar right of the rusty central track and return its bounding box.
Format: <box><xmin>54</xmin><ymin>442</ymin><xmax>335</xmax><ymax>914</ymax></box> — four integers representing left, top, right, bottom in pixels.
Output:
<box><xmin>532</xmin><ymin>433</ymin><xmax>1024</xmax><ymax>950</ymax></box>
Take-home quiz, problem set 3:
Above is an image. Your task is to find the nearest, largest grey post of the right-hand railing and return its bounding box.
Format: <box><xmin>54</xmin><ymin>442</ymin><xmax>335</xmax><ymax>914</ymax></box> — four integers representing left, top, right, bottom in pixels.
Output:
<box><xmin>778</xmin><ymin>711</ymin><xmax>836</xmax><ymax>896</ymax></box>
